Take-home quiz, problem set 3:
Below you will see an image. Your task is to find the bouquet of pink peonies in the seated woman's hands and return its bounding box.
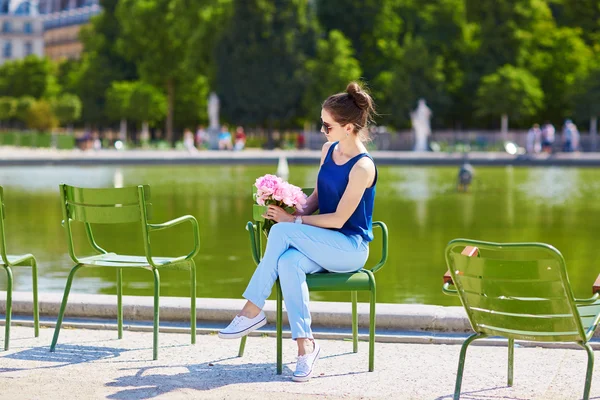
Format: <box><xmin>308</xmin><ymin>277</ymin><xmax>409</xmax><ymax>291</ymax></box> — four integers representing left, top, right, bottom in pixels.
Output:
<box><xmin>254</xmin><ymin>174</ymin><xmax>306</xmax><ymax>234</ymax></box>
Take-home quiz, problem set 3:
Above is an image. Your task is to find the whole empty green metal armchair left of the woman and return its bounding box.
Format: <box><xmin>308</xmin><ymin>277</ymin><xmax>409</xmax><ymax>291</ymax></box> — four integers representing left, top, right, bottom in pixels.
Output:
<box><xmin>50</xmin><ymin>185</ymin><xmax>200</xmax><ymax>360</ymax></box>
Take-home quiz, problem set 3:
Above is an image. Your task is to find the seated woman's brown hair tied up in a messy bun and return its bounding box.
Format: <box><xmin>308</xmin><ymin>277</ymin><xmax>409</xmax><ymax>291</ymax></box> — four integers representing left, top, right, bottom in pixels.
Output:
<box><xmin>322</xmin><ymin>82</ymin><xmax>377</xmax><ymax>142</ymax></box>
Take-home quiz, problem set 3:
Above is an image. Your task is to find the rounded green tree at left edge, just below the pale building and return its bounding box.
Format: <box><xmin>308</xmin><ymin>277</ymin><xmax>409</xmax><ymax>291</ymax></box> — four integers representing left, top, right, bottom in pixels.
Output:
<box><xmin>0</xmin><ymin>55</ymin><xmax>60</xmax><ymax>99</ymax></box>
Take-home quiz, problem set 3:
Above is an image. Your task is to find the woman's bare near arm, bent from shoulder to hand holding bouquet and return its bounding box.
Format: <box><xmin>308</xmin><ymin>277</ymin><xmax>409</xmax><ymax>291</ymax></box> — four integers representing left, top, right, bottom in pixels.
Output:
<box><xmin>265</xmin><ymin>157</ymin><xmax>375</xmax><ymax>229</ymax></box>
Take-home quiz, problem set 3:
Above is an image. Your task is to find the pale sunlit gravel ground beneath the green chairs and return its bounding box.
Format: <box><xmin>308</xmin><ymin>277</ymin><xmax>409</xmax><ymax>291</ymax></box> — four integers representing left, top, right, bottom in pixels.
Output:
<box><xmin>0</xmin><ymin>326</ymin><xmax>600</xmax><ymax>400</ymax></box>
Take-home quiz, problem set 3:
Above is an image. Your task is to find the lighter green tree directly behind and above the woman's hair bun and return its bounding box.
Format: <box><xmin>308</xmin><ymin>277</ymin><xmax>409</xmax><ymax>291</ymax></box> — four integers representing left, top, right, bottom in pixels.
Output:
<box><xmin>303</xmin><ymin>30</ymin><xmax>362</xmax><ymax>120</ymax></box>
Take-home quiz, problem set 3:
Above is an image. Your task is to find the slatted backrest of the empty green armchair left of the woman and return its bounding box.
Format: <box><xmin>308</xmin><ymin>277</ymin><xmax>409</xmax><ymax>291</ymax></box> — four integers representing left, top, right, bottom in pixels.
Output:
<box><xmin>60</xmin><ymin>184</ymin><xmax>152</xmax><ymax>263</ymax></box>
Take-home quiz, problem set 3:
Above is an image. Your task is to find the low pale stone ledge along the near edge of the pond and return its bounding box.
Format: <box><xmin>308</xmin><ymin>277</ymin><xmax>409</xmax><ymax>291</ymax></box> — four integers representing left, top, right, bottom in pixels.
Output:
<box><xmin>0</xmin><ymin>292</ymin><xmax>471</xmax><ymax>332</ymax></box>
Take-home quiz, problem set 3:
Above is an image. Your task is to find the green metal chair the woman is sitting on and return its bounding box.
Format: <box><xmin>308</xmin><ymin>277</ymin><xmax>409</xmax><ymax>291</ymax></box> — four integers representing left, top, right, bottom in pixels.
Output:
<box><xmin>238</xmin><ymin>188</ymin><xmax>388</xmax><ymax>375</ymax></box>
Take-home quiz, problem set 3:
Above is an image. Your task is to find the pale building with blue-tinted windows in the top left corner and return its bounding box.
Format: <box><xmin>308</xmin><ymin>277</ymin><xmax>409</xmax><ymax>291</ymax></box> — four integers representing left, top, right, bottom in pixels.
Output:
<box><xmin>0</xmin><ymin>0</ymin><xmax>44</xmax><ymax>65</ymax></box>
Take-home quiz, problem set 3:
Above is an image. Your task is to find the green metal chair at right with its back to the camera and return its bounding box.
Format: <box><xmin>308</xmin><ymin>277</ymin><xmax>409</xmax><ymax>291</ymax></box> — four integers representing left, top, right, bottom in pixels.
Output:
<box><xmin>443</xmin><ymin>239</ymin><xmax>600</xmax><ymax>400</ymax></box>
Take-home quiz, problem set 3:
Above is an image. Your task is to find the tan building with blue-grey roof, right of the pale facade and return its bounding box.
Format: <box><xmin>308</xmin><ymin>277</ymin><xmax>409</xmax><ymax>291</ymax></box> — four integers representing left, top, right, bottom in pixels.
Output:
<box><xmin>38</xmin><ymin>0</ymin><xmax>101</xmax><ymax>60</ymax></box>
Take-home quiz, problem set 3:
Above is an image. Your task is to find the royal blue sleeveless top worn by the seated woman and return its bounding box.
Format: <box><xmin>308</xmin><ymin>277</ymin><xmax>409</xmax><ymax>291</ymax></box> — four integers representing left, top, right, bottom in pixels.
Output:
<box><xmin>317</xmin><ymin>142</ymin><xmax>377</xmax><ymax>242</ymax></box>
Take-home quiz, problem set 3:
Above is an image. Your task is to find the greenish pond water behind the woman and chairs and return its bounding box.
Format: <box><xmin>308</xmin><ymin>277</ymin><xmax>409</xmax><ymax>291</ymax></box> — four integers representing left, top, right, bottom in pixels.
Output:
<box><xmin>0</xmin><ymin>165</ymin><xmax>600</xmax><ymax>305</ymax></box>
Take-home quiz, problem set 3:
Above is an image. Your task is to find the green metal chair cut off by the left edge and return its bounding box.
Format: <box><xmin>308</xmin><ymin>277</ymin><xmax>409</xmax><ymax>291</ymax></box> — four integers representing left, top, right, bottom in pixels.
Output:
<box><xmin>0</xmin><ymin>186</ymin><xmax>40</xmax><ymax>350</ymax></box>
